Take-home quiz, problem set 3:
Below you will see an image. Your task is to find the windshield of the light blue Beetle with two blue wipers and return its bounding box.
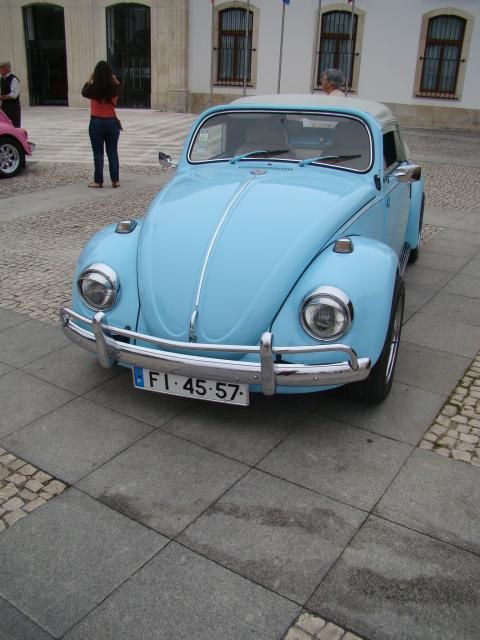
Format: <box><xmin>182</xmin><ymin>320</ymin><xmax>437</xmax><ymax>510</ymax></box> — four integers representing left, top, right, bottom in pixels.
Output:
<box><xmin>188</xmin><ymin>111</ymin><xmax>372</xmax><ymax>171</ymax></box>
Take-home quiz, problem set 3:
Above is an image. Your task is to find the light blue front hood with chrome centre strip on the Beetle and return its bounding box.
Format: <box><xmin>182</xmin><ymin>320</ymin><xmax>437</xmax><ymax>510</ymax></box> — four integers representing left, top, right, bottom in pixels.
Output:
<box><xmin>138</xmin><ymin>165</ymin><xmax>375</xmax><ymax>344</ymax></box>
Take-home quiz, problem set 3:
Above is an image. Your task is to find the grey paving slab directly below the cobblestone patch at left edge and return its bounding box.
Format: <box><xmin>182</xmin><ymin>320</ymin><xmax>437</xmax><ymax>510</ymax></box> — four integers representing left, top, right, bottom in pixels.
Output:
<box><xmin>0</xmin><ymin>489</ymin><xmax>166</xmax><ymax>638</ymax></box>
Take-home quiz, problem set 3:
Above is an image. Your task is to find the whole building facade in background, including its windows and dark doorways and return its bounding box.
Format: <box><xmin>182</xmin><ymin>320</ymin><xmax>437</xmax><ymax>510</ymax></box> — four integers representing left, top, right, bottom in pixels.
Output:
<box><xmin>0</xmin><ymin>0</ymin><xmax>480</xmax><ymax>130</ymax></box>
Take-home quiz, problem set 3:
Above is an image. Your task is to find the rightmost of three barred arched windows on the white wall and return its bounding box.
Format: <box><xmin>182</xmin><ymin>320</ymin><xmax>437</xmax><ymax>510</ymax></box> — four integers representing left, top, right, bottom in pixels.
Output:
<box><xmin>419</xmin><ymin>15</ymin><xmax>466</xmax><ymax>98</ymax></box>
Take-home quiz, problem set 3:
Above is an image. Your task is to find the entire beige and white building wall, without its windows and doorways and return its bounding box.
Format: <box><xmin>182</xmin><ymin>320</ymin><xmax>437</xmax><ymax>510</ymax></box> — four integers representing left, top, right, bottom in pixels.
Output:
<box><xmin>0</xmin><ymin>0</ymin><xmax>480</xmax><ymax>129</ymax></box>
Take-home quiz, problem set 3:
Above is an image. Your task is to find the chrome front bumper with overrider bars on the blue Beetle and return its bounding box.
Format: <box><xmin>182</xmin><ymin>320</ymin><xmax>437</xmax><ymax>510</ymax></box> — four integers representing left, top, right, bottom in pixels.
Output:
<box><xmin>60</xmin><ymin>308</ymin><xmax>370</xmax><ymax>396</ymax></box>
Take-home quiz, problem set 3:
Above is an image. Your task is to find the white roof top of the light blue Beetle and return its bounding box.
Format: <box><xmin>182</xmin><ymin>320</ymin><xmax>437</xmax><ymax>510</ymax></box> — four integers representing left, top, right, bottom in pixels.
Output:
<box><xmin>231</xmin><ymin>93</ymin><xmax>396</xmax><ymax>126</ymax></box>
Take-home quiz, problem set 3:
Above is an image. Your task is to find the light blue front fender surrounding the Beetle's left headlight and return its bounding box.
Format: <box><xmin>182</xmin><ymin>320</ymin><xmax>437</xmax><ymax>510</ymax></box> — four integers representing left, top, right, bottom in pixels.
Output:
<box><xmin>72</xmin><ymin>220</ymin><xmax>142</xmax><ymax>329</ymax></box>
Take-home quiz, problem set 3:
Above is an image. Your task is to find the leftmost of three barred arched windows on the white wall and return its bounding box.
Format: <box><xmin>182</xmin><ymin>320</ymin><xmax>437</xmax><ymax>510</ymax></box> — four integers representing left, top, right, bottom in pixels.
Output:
<box><xmin>216</xmin><ymin>8</ymin><xmax>253</xmax><ymax>86</ymax></box>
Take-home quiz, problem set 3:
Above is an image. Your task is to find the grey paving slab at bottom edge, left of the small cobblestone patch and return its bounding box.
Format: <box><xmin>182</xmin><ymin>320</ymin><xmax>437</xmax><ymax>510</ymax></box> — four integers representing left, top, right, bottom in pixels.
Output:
<box><xmin>64</xmin><ymin>542</ymin><xmax>300</xmax><ymax>640</ymax></box>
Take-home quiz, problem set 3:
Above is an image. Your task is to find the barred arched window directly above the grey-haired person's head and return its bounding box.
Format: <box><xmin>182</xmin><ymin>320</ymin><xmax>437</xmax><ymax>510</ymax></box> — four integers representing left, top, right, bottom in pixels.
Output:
<box><xmin>316</xmin><ymin>11</ymin><xmax>358</xmax><ymax>87</ymax></box>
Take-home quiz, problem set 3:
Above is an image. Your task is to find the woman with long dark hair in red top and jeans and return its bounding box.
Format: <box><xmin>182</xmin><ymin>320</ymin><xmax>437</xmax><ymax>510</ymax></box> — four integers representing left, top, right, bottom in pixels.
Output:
<box><xmin>82</xmin><ymin>60</ymin><xmax>120</xmax><ymax>189</ymax></box>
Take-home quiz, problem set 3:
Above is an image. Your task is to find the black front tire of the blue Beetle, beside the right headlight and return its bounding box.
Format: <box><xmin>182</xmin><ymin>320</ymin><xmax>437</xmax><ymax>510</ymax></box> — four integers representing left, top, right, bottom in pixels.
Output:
<box><xmin>349</xmin><ymin>276</ymin><xmax>405</xmax><ymax>404</ymax></box>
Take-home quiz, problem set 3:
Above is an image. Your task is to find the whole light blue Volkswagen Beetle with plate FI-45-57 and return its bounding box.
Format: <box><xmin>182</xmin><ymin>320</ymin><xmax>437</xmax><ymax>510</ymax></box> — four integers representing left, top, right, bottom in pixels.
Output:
<box><xmin>61</xmin><ymin>95</ymin><xmax>424</xmax><ymax>405</ymax></box>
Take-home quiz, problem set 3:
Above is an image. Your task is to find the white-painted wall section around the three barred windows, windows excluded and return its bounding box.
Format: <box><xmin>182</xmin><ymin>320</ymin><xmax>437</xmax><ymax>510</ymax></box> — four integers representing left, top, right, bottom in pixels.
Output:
<box><xmin>189</xmin><ymin>0</ymin><xmax>480</xmax><ymax>129</ymax></box>
